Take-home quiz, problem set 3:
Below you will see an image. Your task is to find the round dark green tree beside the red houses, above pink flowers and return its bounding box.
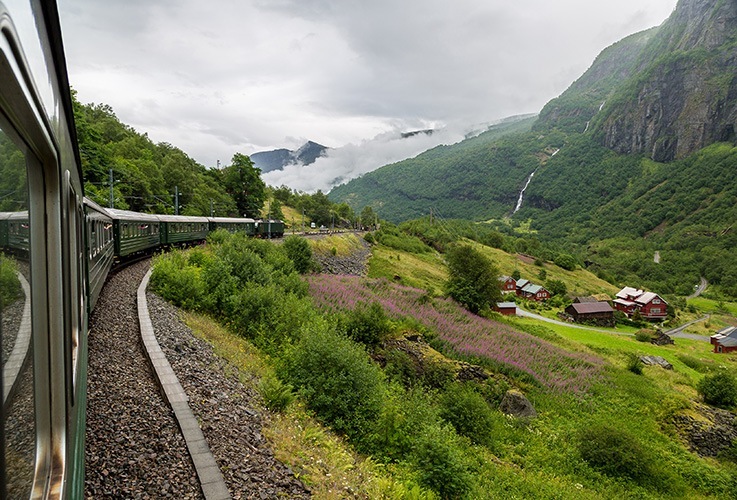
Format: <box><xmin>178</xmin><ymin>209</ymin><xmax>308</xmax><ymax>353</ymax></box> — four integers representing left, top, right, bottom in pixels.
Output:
<box><xmin>445</xmin><ymin>245</ymin><xmax>501</xmax><ymax>313</ymax></box>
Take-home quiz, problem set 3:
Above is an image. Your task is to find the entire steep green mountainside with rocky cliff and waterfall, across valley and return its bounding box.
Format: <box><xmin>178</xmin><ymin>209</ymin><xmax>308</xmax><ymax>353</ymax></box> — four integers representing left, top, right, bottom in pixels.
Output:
<box><xmin>330</xmin><ymin>0</ymin><xmax>737</xmax><ymax>296</ymax></box>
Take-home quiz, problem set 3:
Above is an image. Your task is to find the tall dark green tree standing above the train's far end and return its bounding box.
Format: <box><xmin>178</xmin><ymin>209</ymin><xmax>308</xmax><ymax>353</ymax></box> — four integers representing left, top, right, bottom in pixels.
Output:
<box><xmin>223</xmin><ymin>153</ymin><xmax>266</xmax><ymax>218</ymax></box>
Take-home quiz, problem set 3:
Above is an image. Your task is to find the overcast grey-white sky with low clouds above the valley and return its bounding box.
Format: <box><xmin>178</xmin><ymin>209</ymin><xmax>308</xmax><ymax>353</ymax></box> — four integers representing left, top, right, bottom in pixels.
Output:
<box><xmin>58</xmin><ymin>0</ymin><xmax>676</xmax><ymax>191</ymax></box>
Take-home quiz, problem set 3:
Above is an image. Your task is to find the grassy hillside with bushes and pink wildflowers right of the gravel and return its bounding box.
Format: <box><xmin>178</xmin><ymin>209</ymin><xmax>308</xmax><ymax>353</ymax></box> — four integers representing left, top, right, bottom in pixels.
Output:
<box><xmin>152</xmin><ymin>224</ymin><xmax>737</xmax><ymax>498</ymax></box>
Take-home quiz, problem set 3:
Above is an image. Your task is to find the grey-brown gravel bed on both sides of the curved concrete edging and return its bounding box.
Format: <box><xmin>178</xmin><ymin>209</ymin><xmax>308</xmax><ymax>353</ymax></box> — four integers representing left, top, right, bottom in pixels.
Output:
<box><xmin>85</xmin><ymin>261</ymin><xmax>310</xmax><ymax>499</ymax></box>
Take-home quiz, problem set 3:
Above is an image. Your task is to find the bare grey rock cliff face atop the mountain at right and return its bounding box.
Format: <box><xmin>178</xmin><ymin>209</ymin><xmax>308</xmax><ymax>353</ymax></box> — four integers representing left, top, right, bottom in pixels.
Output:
<box><xmin>595</xmin><ymin>0</ymin><xmax>737</xmax><ymax>161</ymax></box>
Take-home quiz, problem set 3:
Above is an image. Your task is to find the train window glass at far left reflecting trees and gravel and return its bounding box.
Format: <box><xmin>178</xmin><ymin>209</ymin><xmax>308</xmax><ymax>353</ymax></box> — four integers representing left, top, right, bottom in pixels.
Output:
<box><xmin>0</xmin><ymin>124</ymin><xmax>36</xmax><ymax>498</ymax></box>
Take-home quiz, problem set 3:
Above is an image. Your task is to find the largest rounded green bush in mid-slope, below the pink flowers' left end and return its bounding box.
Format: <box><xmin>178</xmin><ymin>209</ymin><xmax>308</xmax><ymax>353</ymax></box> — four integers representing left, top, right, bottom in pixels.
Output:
<box><xmin>280</xmin><ymin>322</ymin><xmax>385</xmax><ymax>437</ymax></box>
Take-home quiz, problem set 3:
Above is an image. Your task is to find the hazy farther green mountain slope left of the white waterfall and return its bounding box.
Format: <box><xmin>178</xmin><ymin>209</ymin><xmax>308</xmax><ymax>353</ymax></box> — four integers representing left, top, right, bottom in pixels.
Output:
<box><xmin>330</xmin><ymin>117</ymin><xmax>540</xmax><ymax>221</ymax></box>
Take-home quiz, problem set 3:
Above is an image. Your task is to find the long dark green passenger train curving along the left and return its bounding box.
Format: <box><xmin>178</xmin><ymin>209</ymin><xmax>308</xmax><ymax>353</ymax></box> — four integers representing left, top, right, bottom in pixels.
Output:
<box><xmin>0</xmin><ymin>0</ymin><xmax>284</xmax><ymax>498</ymax></box>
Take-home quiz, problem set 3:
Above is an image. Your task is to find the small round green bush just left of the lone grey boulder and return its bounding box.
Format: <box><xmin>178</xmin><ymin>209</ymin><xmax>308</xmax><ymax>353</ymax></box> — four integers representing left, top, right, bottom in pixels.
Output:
<box><xmin>440</xmin><ymin>384</ymin><xmax>494</xmax><ymax>446</ymax></box>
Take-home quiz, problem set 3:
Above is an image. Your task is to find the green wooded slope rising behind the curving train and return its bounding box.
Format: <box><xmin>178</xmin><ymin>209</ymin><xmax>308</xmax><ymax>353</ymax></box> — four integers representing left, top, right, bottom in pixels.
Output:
<box><xmin>71</xmin><ymin>91</ymin><xmax>375</xmax><ymax>223</ymax></box>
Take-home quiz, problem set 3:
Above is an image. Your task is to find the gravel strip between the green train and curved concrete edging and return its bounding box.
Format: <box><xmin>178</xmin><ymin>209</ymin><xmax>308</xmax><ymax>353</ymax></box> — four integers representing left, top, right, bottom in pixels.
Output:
<box><xmin>85</xmin><ymin>261</ymin><xmax>203</xmax><ymax>499</ymax></box>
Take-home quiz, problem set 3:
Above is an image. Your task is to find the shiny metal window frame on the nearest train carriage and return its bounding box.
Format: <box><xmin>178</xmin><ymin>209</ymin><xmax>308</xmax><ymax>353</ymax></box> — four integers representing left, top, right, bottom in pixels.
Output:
<box><xmin>0</xmin><ymin>2</ymin><xmax>81</xmax><ymax>495</ymax></box>
